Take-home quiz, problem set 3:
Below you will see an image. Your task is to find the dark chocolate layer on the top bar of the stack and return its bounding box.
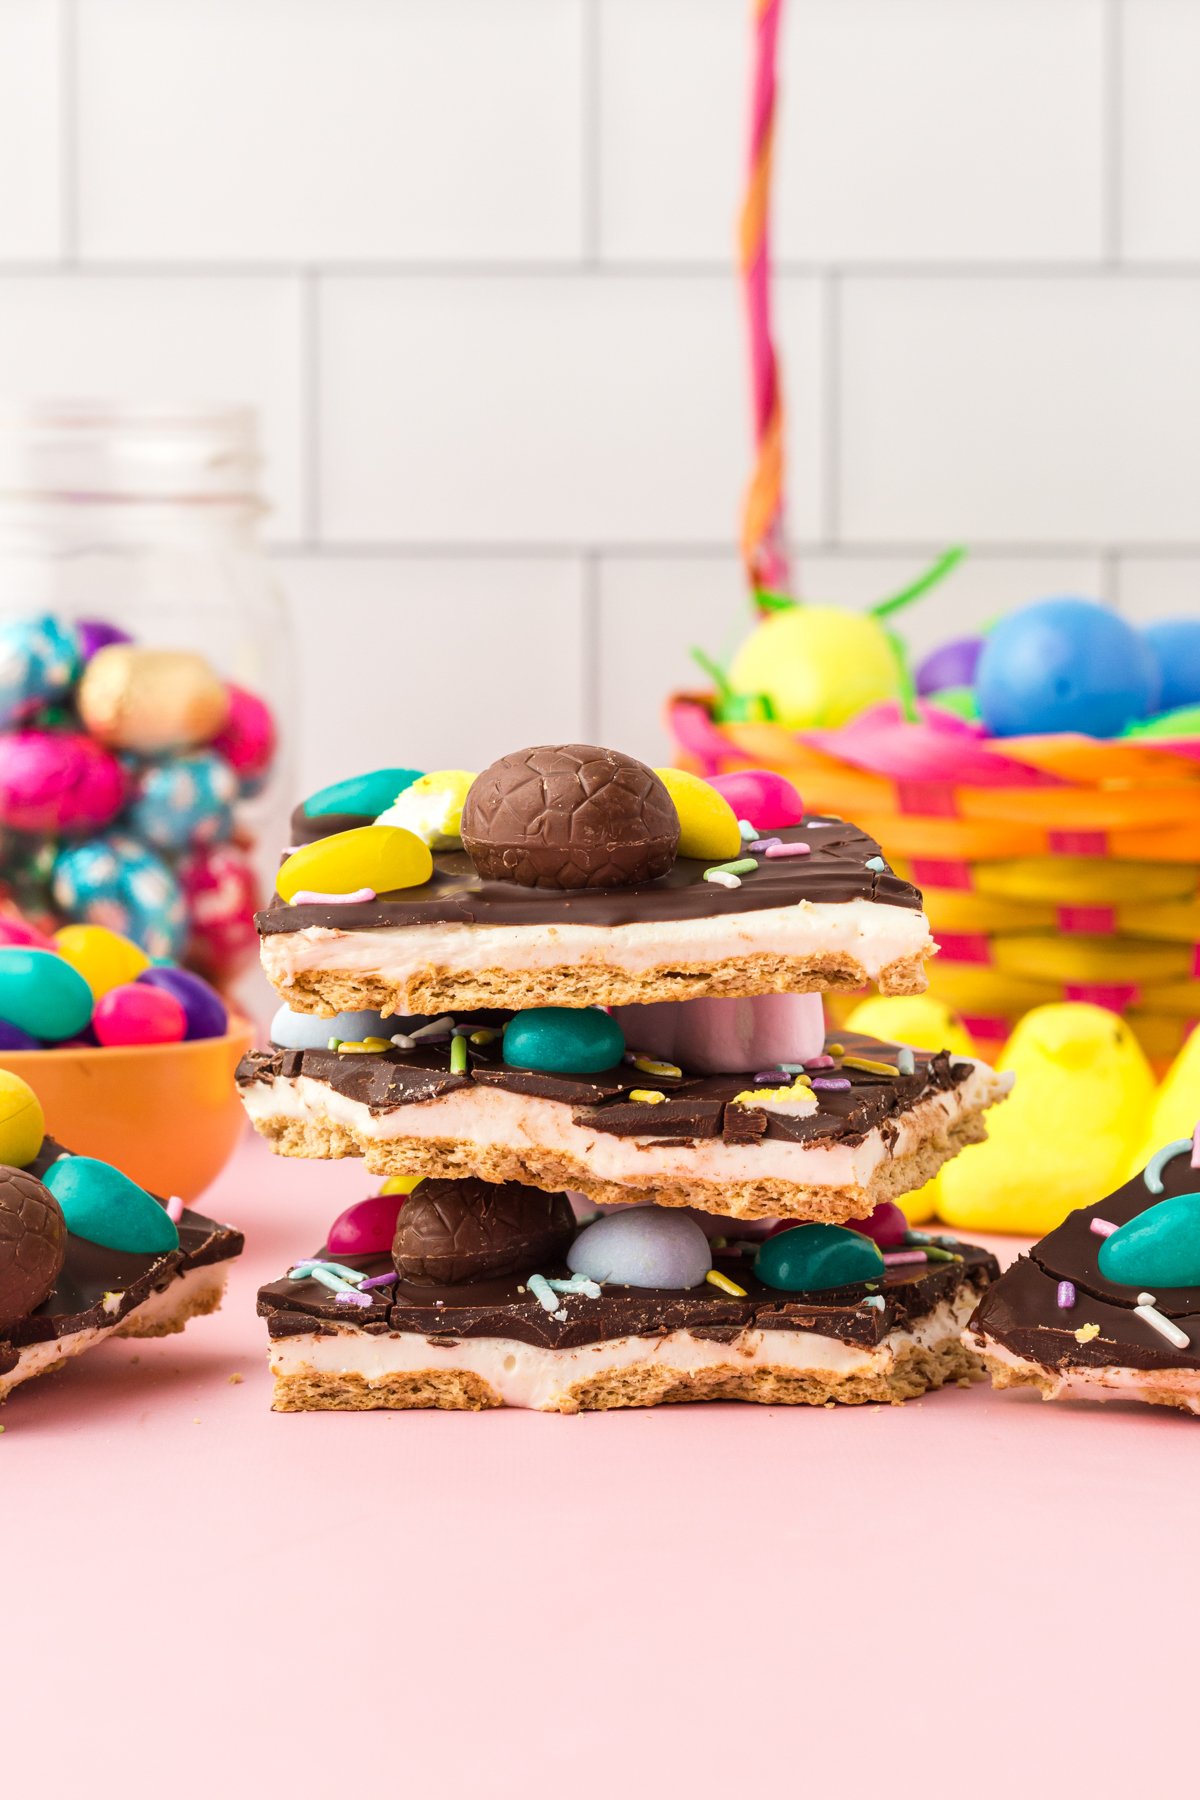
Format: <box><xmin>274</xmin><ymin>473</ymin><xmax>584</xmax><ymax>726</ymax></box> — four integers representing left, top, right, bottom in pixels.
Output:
<box><xmin>255</xmin><ymin>817</ymin><xmax>921</xmax><ymax>936</ymax></box>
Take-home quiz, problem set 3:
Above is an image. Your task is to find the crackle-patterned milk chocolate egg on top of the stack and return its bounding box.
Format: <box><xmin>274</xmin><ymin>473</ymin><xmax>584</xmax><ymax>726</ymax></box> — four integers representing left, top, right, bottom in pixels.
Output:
<box><xmin>462</xmin><ymin>743</ymin><xmax>680</xmax><ymax>889</ymax></box>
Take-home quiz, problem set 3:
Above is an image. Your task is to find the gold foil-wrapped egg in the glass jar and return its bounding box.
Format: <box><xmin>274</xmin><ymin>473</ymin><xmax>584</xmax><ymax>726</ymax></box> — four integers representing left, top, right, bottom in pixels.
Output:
<box><xmin>77</xmin><ymin>644</ymin><xmax>228</xmax><ymax>756</ymax></box>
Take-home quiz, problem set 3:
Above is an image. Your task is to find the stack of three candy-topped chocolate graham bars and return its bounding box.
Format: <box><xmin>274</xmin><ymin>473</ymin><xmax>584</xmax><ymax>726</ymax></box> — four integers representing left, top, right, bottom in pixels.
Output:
<box><xmin>239</xmin><ymin>745</ymin><xmax>1004</xmax><ymax>1411</ymax></box>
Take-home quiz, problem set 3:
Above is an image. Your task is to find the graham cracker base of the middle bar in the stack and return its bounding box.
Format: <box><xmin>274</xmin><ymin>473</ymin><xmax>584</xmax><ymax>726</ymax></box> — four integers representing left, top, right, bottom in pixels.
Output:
<box><xmin>254</xmin><ymin>1112</ymin><xmax>988</xmax><ymax>1226</ymax></box>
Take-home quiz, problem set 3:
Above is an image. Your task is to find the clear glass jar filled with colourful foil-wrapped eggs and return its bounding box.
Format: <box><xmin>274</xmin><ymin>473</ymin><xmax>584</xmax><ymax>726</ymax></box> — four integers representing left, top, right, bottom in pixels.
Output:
<box><xmin>0</xmin><ymin>403</ymin><xmax>291</xmax><ymax>988</ymax></box>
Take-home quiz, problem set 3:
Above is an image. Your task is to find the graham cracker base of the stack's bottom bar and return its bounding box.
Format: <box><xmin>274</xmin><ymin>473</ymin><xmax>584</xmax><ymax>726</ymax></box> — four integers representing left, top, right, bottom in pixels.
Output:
<box><xmin>272</xmin><ymin>1336</ymin><xmax>979</xmax><ymax>1413</ymax></box>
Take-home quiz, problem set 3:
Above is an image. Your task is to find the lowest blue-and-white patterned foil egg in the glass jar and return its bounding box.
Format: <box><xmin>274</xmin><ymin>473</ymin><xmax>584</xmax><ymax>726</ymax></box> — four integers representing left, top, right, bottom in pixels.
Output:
<box><xmin>50</xmin><ymin>833</ymin><xmax>187</xmax><ymax>958</ymax></box>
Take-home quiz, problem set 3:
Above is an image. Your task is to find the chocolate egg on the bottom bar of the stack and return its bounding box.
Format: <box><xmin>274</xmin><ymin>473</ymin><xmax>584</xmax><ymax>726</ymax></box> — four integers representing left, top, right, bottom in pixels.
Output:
<box><xmin>392</xmin><ymin>1179</ymin><xmax>576</xmax><ymax>1287</ymax></box>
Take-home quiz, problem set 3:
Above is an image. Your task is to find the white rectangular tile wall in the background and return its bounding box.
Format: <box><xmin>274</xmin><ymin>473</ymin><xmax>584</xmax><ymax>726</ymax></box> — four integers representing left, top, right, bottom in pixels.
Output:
<box><xmin>0</xmin><ymin>0</ymin><xmax>1200</xmax><ymax>785</ymax></box>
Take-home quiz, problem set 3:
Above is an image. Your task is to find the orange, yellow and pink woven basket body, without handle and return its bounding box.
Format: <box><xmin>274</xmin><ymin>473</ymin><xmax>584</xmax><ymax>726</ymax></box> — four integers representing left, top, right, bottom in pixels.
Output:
<box><xmin>667</xmin><ymin>693</ymin><xmax>1200</xmax><ymax>1066</ymax></box>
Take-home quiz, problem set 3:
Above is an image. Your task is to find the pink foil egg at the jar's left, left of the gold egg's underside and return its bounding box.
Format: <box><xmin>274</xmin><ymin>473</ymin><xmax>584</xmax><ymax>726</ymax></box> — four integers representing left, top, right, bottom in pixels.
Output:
<box><xmin>0</xmin><ymin>731</ymin><xmax>126</xmax><ymax>837</ymax></box>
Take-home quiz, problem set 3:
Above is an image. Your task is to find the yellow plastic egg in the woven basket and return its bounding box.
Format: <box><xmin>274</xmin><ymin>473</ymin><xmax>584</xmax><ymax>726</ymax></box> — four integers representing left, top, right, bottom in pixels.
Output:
<box><xmin>729</xmin><ymin>607</ymin><xmax>900</xmax><ymax>730</ymax></box>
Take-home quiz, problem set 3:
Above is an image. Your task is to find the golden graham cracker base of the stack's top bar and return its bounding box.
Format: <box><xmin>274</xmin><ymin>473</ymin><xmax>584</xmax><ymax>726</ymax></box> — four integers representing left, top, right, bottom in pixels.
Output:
<box><xmin>264</xmin><ymin>943</ymin><xmax>934</xmax><ymax>1019</ymax></box>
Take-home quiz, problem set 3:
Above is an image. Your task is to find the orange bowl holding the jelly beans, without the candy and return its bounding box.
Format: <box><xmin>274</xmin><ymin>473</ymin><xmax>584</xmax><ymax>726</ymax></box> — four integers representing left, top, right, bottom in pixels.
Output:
<box><xmin>0</xmin><ymin>1019</ymin><xmax>254</xmax><ymax>1202</ymax></box>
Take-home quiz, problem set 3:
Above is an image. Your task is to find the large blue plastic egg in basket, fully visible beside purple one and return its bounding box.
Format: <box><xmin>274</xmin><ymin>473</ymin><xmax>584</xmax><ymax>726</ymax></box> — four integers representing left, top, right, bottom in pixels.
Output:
<box><xmin>975</xmin><ymin>599</ymin><xmax>1159</xmax><ymax>738</ymax></box>
